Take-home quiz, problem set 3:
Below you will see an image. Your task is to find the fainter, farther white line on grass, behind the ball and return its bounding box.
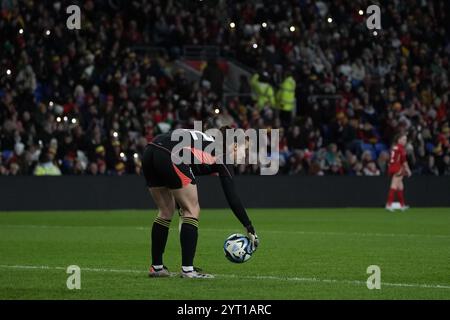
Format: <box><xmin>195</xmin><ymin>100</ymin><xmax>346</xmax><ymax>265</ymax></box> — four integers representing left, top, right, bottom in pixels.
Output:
<box><xmin>0</xmin><ymin>224</ymin><xmax>450</xmax><ymax>239</ymax></box>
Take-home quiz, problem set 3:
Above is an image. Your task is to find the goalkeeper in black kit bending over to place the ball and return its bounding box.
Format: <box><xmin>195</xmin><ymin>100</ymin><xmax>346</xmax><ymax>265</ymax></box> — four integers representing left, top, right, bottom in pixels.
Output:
<box><xmin>142</xmin><ymin>128</ymin><xmax>259</xmax><ymax>278</ymax></box>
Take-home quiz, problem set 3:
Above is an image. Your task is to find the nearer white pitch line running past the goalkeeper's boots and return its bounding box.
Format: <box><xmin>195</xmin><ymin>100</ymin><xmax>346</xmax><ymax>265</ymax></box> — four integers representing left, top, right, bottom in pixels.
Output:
<box><xmin>0</xmin><ymin>265</ymin><xmax>450</xmax><ymax>289</ymax></box>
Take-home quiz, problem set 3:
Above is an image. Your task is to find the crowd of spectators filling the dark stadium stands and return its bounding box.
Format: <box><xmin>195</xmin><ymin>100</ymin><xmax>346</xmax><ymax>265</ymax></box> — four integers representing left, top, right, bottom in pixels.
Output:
<box><xmin>0</xmin><ymin>0</ymin><xmax>450</xmax><ymax>176</ymax></box>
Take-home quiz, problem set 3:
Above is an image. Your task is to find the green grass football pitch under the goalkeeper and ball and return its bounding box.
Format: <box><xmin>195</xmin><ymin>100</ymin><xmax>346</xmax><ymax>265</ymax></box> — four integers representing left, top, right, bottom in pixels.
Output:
<box><xmin>0</xmin><ymin>208</ymin><xmax>450</xmax><ymax>299</ymax></box>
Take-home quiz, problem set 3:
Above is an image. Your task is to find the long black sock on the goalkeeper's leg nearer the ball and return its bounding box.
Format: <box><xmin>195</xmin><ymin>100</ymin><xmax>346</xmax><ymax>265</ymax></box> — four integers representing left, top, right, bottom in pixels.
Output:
<box><xmin>180</xmin><ymin>217</ymin><xmax>198</xmax><ymax>267</ymax></box>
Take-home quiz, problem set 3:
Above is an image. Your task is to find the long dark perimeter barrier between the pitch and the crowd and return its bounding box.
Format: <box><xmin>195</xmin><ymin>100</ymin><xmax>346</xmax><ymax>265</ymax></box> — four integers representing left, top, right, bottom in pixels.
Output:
<box><xmin>0</xmin><ymin>176</ymin><xmax>450</xmax><ymax>211</ymax></box>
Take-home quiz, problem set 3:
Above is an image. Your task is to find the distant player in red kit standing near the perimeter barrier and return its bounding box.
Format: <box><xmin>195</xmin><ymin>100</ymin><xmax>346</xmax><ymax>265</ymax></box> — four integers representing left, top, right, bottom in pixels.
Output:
<box><xmin>386</xmin><ymin>134</ymin><xmax>411</xmax><ymax>211</ymax></box>
